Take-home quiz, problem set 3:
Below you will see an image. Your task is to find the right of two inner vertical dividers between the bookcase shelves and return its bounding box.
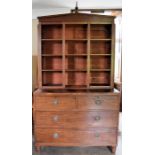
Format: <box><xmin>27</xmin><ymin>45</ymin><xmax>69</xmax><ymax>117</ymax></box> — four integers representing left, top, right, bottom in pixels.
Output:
<box><xmin>87</xmin><ymin>23</ymin><xmax>90</xmax><ymax>88</ymax></box>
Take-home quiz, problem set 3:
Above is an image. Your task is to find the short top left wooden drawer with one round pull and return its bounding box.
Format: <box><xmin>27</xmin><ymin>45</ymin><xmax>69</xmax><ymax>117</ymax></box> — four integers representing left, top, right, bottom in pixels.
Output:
<box><xmin>35</xmin><ymin>96</ymin><xmax>76</xmax><ymax>111</ymax></box>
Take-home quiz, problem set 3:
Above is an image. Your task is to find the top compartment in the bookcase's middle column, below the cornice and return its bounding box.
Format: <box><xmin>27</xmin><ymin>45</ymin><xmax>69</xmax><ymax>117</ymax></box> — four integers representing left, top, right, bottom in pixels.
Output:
<box><xmin>65</xmin><ymin>24</ymin><xmax>87</xmax><ymax>39</ymax></box>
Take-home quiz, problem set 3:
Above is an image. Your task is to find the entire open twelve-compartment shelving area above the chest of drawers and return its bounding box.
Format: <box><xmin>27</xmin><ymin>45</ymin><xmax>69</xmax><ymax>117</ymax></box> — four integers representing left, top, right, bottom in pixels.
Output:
<box><xmin>40</xmin><ymin>23</ymin><xmax>113</xmax><ymax>90</ymax></box>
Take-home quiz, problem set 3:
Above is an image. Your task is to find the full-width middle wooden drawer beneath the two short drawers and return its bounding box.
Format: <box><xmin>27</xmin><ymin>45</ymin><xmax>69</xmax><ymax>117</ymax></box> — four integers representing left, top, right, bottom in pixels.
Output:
<box><xmin>35</xmin><ymin>111</ymin><xmax>118</xmax><ymax>129</ymax></box>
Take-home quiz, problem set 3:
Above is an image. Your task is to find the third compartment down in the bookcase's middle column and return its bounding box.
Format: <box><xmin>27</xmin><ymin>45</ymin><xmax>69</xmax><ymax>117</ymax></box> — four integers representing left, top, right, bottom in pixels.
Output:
<box><xmin>65</xmin><ymin>57</ymin><xmax>87</xmax><ymax>70</ymax></box>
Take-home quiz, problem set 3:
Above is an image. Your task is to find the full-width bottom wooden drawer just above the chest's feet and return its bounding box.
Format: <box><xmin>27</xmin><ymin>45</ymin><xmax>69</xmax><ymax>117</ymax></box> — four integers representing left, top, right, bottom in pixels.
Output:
<box><xmin>35</xmin><ymin>128</ymin><xmax>117</xmax><ymax>146</ymax></box>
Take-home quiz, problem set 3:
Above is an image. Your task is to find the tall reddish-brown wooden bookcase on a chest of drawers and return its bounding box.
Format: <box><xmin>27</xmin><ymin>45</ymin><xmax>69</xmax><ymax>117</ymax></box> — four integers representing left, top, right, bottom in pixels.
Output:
<box><xmin>33</xmin><ymin>13</ymin><xmax>120</xmax><ymax>152</ymax></box>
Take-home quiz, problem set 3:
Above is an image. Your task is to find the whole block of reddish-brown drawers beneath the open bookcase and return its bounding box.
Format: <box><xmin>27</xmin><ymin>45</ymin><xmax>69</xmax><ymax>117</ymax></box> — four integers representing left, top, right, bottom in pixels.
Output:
<box><xmin>34</xmin><ymin>94</ymin><xmax>119</xmax><ymax>146</ymax></box>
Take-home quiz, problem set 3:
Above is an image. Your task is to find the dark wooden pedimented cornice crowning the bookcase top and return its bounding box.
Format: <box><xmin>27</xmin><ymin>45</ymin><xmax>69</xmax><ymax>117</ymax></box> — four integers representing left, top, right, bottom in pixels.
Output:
<box><xmin>38</xmin><ymin>13</ymin><xmax>115</xmax><ymax>24</ymax></box>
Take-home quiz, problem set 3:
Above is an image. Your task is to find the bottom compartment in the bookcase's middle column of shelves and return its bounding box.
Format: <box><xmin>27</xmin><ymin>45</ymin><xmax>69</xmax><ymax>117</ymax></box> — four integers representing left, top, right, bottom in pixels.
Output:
<box><xmin>65</xmin><ymin>72</ymin><xmax>87</xmax><ymax>87</ymax></box>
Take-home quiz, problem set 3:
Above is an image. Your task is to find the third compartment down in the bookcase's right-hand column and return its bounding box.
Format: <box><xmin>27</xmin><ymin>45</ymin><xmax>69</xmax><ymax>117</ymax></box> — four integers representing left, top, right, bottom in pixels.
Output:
<box><xmin>90</xmin><ymin>56</ymin><xmax>111</xmax><ymax>70</ymax></box>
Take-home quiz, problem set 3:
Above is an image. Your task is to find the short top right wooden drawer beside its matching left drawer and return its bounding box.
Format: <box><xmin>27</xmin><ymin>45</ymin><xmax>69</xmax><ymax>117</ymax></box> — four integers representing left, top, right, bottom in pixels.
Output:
<box><xmin>77</xmin><ymin>95</ymin><xmax>119</xmax><ymax>110</ymax></box>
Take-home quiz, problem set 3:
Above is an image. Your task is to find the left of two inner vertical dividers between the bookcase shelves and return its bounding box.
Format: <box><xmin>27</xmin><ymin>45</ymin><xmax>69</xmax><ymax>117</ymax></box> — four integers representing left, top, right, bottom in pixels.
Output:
<box><xmin>62</xmin><ymin>23</ymin><xmax>66</xmax><ymax>88</ymax></box>
